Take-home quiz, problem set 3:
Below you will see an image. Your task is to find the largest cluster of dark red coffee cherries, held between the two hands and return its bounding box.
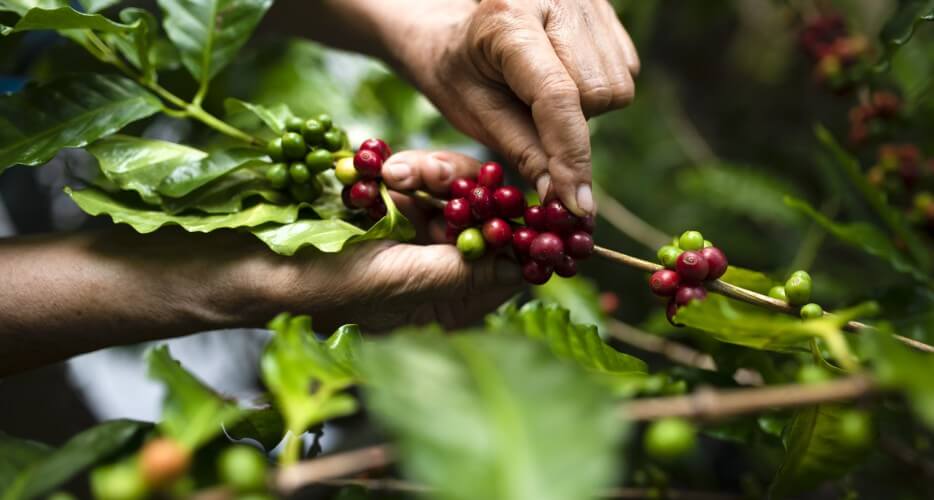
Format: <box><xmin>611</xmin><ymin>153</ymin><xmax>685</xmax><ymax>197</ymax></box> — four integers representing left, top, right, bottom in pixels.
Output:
<box><xmin>444</xmin><ymin>162</ymin><xmax>594</xmax><ymax>285</ymax></box>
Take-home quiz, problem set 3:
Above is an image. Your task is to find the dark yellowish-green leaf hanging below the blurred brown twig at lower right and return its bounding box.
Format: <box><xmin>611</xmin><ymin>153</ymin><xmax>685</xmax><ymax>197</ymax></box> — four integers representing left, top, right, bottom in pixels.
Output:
<box><xmin>769</xmin><ymin>405</ymin><xmax>869</xmax><ymax>498</ymax></box>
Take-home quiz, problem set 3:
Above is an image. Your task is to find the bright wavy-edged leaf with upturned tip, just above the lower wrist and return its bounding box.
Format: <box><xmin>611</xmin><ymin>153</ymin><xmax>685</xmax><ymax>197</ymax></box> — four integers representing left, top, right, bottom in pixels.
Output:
<box><xmin>252</xmin><ymin>185</ymin><xmax>415</xmax><ymax>255</ymax></box>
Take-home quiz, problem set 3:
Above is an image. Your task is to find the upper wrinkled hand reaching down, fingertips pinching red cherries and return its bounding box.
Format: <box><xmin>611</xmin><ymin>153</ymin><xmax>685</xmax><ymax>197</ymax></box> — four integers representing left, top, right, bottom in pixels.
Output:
<box><xmin>380</xmin><ymin>0</ymin><xmax>639</xmax><ymax>215</ymax></box>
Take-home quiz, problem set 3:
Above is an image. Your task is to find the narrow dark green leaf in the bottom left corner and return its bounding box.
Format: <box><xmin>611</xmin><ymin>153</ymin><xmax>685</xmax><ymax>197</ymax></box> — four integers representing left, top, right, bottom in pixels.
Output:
<box><xmin>0</xmin><ymin>420</ymin><xmax>152</xmax><ymax>500</ymax></box>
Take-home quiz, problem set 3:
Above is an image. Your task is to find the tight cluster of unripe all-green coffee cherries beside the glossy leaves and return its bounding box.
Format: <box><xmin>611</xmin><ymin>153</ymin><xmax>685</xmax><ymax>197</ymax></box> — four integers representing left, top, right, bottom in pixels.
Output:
<box><xmin>265</xmin><ymin>114</ymin><xmax>347</xmax><ymax>203</ymax></box>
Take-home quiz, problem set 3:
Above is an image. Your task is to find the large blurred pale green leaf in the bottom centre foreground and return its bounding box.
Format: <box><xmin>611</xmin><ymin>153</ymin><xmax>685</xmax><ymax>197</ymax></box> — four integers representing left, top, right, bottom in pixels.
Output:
<box><xmin>361</xmin><ymin>330</ymin><xmax>625</xmax><ymax>500</ymax></box>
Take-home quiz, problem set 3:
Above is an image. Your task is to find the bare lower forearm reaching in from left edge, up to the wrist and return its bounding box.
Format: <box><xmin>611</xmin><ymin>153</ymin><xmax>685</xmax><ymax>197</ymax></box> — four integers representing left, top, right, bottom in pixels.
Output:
<box><xmin>0</xmin><ymin>228</ymin><xmax>284</xmax><ymax>376</ymax></box>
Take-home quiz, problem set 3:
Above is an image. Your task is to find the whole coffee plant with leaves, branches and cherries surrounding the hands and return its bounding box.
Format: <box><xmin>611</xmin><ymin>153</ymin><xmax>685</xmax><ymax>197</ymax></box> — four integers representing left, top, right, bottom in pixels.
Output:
<box><xmin>0</xmin><ymin>0</ymin><xmax>934</xmax><ymax>500</ymax></box>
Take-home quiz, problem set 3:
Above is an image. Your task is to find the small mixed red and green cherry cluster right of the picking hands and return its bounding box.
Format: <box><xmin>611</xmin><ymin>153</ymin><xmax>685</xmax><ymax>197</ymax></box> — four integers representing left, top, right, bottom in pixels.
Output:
<box><xmin>649</xmin><ymin>231</ymin><xmax>729</xmax><ymax>326</ymax></box>
